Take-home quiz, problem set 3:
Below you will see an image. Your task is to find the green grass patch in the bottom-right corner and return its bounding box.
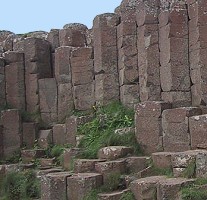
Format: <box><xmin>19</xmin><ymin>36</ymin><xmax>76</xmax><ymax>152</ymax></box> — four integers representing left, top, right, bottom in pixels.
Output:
<box><xmin>181</xmin><ymin>178</ymin><xmax>207</xmax><ymax>200</ymax></box>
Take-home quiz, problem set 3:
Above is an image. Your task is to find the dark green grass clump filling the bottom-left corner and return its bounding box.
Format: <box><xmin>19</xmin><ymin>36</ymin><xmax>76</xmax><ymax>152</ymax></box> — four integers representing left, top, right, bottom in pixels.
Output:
<box><xmin>0</xmin><ymin>170</ymin><xmax>40</xmax><ymax>200</ymax></box>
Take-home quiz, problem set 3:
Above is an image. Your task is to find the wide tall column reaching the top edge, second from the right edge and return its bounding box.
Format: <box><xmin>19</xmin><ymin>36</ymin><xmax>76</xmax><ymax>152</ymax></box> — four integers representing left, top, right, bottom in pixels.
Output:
<box><xmin>159</xmin><ymin>1</ymin><xmax>191</xmax><ymax>107</ymax></box>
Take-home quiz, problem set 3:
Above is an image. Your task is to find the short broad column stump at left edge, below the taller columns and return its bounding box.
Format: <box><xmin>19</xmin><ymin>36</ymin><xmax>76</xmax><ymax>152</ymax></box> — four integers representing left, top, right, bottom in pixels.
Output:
<box><xmin>1</xmin><ymin>109</ymin><xmax>22</xmax><ymax>158</ymax></box>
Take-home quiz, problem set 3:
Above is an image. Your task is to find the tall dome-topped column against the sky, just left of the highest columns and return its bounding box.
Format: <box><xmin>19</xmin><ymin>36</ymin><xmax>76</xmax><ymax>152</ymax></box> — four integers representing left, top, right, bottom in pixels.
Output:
<box><xmin>93</xmin><ymin>13</ymin><xmax>119</xmax><ymax>104</ymax></box>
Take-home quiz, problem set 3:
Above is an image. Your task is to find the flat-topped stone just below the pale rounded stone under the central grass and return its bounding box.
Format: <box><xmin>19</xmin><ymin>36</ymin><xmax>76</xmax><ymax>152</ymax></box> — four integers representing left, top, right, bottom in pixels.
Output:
<box><xmin>95</xmin><ymin>159</ymin><xmax>126</xmax><ymax>184</ymax></box>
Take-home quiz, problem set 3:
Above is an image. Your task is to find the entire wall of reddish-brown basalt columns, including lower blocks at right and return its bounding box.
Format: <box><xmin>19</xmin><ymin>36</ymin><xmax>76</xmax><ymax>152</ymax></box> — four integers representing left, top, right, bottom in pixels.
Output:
<box><xmin>0</xmin><ymin>0</ymin><xmax>207</xmax><ymax>166</ymax></box>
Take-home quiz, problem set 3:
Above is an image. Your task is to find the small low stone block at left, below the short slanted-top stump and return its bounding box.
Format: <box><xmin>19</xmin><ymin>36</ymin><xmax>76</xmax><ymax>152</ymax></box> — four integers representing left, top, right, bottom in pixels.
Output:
<box><xmin>21</xmin><ymin>149</ymin><xmax>45</xmax><ymax>163</ymax></box>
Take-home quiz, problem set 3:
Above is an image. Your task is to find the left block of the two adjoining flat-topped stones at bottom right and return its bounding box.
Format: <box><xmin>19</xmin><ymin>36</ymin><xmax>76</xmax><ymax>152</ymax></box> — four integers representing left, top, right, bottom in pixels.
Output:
<box><xmin>130</xmin><ymin>176</ymin><xmax>165</xmax><ymax>200</ymax></box>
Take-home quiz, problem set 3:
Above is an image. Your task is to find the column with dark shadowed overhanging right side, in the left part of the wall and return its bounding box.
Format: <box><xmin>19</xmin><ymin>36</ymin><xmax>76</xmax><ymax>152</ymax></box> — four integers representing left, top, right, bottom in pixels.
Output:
<box><xmin>24</xmin><ymin>38</ymin><xmax>52</xmax><ymax>112</ymax></box>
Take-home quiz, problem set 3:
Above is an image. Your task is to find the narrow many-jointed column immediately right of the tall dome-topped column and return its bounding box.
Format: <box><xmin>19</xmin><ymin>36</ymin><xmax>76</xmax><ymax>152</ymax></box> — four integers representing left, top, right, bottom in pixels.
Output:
<box><xmin>117</xmin><ymin>6</ymin><xmax>139</xmax><ymax>107</ymax></box>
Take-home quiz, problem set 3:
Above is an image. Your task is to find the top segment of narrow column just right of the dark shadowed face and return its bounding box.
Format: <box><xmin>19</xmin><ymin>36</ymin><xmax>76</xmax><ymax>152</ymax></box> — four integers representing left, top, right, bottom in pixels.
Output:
<box><xmin>55</xmin><ymin>46</ymin><xmax>72</xmax><ymax>84</ymax></box>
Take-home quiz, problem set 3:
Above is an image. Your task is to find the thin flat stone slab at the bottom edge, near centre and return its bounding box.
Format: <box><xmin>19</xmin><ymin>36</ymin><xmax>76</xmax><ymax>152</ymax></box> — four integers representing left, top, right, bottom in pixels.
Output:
<box><xmin>98</xmin><ymin>189</ymin><xmax>130</xmax><ymax>200</ymax></box>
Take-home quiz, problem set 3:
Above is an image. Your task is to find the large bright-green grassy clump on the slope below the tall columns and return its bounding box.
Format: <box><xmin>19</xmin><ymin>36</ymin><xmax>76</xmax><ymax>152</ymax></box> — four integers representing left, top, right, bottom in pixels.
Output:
<box><xmin>78</xmin><ymin>102</ymin><xmax>140</xmax><ymax>158</ymax></box>
